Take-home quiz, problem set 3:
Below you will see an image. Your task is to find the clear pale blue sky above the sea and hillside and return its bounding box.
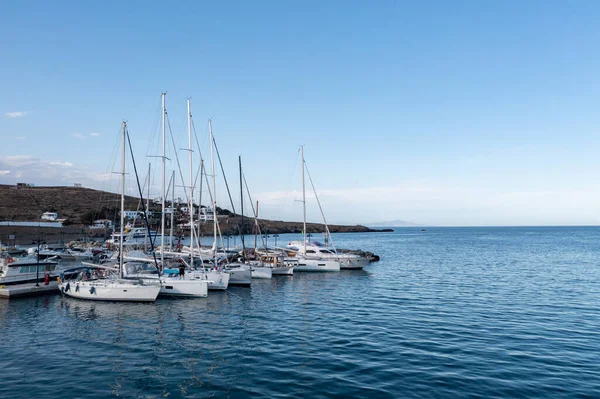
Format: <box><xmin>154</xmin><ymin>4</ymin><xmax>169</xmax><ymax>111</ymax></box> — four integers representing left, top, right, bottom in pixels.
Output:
<box><xmin>0</xmin><ymin>0</ymin><xmax>600</xmax><ymax>226</ymax></box>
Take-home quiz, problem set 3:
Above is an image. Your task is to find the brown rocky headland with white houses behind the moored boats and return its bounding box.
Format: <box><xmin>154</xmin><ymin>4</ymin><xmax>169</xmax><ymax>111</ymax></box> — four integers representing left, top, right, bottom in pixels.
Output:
<box><xmin>0</xmin><ymin>184</ymin><xmax>391</xmax><ymax>244</ymax></box>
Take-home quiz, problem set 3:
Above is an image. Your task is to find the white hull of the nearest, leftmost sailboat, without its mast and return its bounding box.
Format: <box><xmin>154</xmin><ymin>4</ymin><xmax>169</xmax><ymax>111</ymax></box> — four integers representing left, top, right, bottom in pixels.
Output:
<box><xmin>58</xmin><ymin>279</ymin><xmax>161</xmax><ymax>302</ymax></box>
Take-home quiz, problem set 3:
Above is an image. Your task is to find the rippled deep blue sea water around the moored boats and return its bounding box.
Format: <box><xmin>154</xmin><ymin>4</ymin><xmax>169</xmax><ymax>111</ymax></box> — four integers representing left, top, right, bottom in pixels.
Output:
<box><xmin>0</xmin><ymin>227</ymin><xmax>600</xmax><ymax>398</ymax></box>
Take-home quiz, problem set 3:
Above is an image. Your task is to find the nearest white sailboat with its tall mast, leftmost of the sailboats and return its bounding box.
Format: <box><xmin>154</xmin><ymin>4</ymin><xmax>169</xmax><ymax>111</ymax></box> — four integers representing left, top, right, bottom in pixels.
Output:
<box><xmin>58</xmin><ymin>122</ymin><xmax>161</xmax><ymax>302</ymax></box>
